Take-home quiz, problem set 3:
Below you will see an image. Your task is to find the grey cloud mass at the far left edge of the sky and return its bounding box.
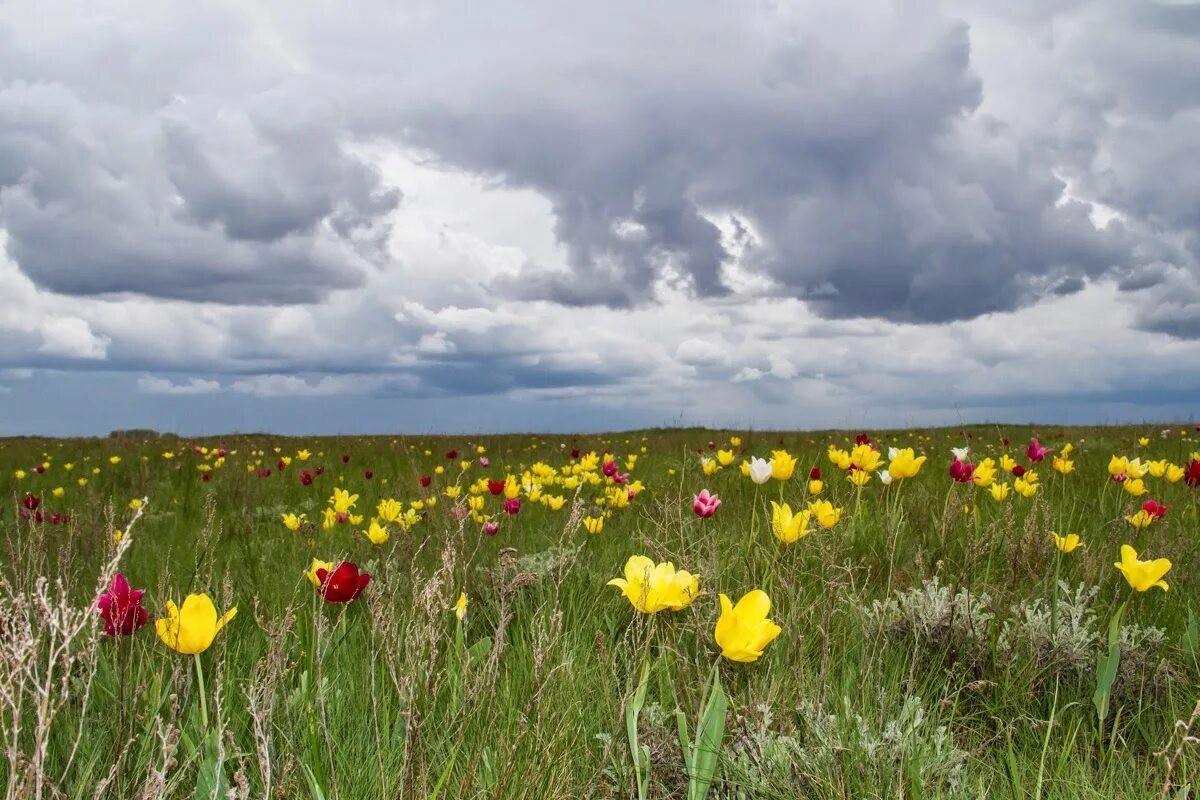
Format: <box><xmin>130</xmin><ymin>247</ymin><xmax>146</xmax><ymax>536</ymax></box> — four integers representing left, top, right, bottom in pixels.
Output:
<box><xmin>0</xmin><ymin>21</ymin><xmax>398</xmax><ymax>303</ymax></box>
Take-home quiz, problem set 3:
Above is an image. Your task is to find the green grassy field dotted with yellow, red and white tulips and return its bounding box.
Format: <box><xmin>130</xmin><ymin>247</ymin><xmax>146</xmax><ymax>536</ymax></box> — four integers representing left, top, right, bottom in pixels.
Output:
<box><xmin>0</xmin><ymin>426</ymin><xmax>1200</xmax><ymax>800</ymax></box>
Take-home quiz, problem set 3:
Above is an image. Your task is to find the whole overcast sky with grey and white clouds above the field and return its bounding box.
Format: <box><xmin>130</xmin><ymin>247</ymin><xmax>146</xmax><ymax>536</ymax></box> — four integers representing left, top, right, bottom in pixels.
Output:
<box><xmin>0</xmin><ymin>0</ymin><xmax>1200</xmax><ymax>435</ymax></box>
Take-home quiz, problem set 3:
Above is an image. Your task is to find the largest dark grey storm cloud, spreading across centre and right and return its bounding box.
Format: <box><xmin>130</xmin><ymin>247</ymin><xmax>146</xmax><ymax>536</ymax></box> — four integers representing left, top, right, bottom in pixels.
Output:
<box><xmin>324</xmin><ymin>2</ymin><xmax>1142</xmax><ymax>321</ymax></box>
